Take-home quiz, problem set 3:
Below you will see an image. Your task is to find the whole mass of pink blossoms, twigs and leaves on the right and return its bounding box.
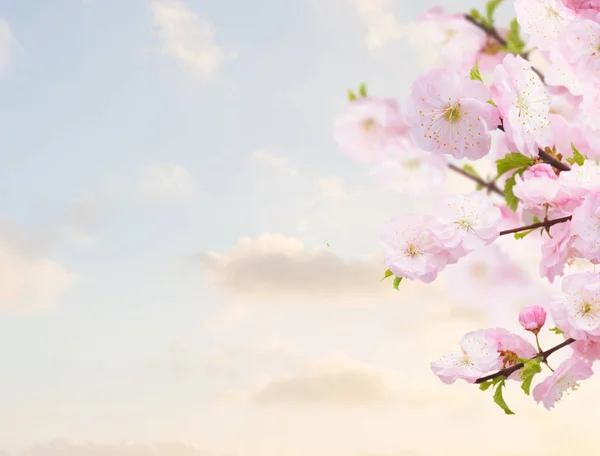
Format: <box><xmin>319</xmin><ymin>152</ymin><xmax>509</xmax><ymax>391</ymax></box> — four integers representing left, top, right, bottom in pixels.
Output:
<box><xmin>334</xmin><ymin>0</ymin><xmax>600</xmax><ymax>413</ymax></box>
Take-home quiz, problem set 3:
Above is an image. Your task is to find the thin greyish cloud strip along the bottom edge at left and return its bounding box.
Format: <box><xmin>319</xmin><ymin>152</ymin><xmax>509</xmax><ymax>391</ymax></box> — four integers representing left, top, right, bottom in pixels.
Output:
<box><xmin>23</xmin><ymin>441</ymin><xmax>206</xmax><ymax>456</ymax></box>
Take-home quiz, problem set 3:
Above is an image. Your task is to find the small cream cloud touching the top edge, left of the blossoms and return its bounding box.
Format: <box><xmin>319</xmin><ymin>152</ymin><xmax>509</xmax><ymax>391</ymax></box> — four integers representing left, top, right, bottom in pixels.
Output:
<box><xmin>355</xmin><ymin>0</ymin><xmax>406</xmax><ymax>51</ymax></box>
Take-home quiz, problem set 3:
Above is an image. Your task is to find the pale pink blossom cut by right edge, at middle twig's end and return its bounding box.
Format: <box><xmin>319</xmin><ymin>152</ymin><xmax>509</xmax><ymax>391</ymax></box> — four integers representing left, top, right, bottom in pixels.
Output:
<box><xmin>571</xmin><ymin>192</ymin><xmax>600</xmax><ymax>263</ymax></box>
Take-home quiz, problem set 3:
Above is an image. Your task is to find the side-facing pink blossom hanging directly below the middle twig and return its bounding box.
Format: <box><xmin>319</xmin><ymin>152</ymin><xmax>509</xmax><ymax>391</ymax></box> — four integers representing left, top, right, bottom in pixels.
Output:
<box><xmin>540</xmin><ymin>221</ymin><xmax>578</xmax><ymax>283</ymax></box>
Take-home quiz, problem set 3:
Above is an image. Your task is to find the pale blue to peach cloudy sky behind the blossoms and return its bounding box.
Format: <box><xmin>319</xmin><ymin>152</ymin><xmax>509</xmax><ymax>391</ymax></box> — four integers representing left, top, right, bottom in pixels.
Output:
<box><xmin>0</xmin><ymin>0</ymin><xmax>600</xmax><ymax>456</ymax></box>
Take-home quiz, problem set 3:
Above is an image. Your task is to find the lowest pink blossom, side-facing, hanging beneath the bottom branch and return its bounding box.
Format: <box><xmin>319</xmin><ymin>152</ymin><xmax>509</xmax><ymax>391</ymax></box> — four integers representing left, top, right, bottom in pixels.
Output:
<box><xmin>533</xmin><ymin>357</ymin><xmax>594</xmax><ymax>410</ymax></box>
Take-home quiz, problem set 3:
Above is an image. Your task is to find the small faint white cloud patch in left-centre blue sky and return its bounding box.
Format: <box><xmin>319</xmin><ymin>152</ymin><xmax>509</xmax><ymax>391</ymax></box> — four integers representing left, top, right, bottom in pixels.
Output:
<box><xmin>136</xmin><ymin>163</ymin><xmax>192</xmax><ymax>200</ymax></box>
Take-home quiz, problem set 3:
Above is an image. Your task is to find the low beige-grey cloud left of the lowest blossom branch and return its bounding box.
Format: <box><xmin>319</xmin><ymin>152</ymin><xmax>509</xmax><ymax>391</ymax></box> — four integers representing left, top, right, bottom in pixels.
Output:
<box><xmin>252</xmin><ymin>356</ymin><xmax>395</xmax><ymax>405</ymax></box>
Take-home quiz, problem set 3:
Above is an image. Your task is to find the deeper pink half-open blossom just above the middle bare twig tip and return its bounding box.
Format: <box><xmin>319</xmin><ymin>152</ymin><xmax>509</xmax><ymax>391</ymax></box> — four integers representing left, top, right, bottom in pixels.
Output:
<box><xmin>513</xmin><ymin>163</ymin><xmax>561</xmax><ymax>214</ymax></box>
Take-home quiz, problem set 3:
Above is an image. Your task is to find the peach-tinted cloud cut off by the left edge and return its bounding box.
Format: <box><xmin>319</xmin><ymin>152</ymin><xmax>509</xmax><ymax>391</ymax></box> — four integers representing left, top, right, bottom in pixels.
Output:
<box><xmin>0</xmin><ymin>243</ymin><xmax>75</xmax><ymax>314</ymax></box>
